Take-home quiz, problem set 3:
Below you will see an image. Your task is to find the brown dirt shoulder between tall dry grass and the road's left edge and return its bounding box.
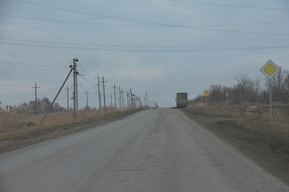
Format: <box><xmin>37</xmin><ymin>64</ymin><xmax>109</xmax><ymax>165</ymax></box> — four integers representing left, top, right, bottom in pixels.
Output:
<box><xmin>0</xmin><ymin>110</ymin><xmax>139</xmax><ymax>154</ymax></box>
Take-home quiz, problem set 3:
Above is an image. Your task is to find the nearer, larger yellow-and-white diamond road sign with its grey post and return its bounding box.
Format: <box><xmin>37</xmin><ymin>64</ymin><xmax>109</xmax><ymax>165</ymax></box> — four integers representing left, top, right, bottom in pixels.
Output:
<box><xmin>260</xmin><ymin>60</ymin><xmax>280</xmax><ymax>123</ymax></box>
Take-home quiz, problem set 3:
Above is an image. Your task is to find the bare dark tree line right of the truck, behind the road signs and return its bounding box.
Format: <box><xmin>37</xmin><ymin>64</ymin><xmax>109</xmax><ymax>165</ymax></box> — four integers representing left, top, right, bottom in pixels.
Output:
<box><xmin>190</xmin><ymin>70</ymin><xmax>289</xmax><ymax>105</ymax></box>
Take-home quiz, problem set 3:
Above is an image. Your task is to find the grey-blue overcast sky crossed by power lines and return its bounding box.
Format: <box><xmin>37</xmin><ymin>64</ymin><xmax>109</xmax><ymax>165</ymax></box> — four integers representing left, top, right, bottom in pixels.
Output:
<box><xmin>0</xmin><ymin>0</ymin><xmax>289</xmax><ymax>108</ymax></box>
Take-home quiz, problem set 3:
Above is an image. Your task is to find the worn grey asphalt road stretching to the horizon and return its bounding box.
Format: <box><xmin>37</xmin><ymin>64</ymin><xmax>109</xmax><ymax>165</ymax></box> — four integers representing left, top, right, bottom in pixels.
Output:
<box><xmin>0</xmin><ymin>109</ymin><xmax>289</xmax><ymax>192</ymax></box>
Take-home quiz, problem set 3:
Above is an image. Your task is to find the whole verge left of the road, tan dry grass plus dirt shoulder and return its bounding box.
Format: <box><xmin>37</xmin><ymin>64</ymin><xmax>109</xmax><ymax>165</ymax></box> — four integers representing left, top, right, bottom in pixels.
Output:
<box><xmin>0</xmin><ymin>108</ymin><xmax>140</xmax><ymax>153</ymax></box>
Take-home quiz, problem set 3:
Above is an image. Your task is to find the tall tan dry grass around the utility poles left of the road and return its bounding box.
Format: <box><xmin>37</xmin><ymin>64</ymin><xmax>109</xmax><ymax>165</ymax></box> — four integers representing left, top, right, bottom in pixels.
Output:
<box><xmin>0</xmin><ymin>108</ymin><xmax>134</xmax><ymax>139</ymax></box>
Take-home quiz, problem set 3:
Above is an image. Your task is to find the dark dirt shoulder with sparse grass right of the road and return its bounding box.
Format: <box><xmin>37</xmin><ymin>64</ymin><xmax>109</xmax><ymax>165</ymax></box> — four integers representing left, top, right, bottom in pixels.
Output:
<box><xmin>182</xmin><ymin>108</ymin><xmax>289</xmax><ymax>185</ymax></box>
